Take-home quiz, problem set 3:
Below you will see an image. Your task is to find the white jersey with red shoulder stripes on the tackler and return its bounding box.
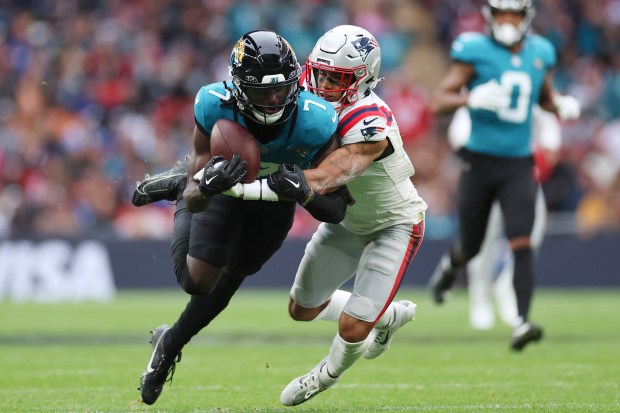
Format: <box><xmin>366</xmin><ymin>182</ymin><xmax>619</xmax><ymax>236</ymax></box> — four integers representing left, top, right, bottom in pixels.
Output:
<box><xmin>338</xmin><ymin>92</ymin><xmax>427</xmax><ymax>234</ymax></box>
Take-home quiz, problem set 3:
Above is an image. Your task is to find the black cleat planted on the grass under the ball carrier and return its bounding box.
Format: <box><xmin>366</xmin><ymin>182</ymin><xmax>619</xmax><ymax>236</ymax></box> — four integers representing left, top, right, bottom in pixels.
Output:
<box><xmin>138</xmin><ymin>324</ymin><xmax>181</xmax><ymax>404</ymax></box>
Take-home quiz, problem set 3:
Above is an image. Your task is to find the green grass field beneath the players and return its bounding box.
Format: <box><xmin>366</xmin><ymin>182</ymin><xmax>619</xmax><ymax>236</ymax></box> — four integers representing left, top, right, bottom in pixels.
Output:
<box><xmin>0</xmin><ymin>289</ymin><xmax>620</xmax><ymax>413</ymax></box>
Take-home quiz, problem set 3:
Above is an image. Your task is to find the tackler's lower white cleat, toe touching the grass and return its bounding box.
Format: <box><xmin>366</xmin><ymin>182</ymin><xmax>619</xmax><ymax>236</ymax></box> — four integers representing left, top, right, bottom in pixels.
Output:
<box><xmin>280</xmin><ymin>357</ymin><xmax>338</xmax><ymax>406</ymax></box>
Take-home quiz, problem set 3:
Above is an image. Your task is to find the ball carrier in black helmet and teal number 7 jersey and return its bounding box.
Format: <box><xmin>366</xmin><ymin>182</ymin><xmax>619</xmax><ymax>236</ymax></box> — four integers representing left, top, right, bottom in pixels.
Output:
<box><xmin>133</xmin><ymin>31</ymin><xmax>350</xmax><ymax>404</ymax></box>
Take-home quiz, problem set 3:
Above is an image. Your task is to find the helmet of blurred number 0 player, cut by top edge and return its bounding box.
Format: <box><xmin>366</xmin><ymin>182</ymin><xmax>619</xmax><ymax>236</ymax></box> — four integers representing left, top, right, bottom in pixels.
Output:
<box><xmin>482</xmin><ymin>0</ymin><xmax>536</xmax><ymax>47</ymax></box>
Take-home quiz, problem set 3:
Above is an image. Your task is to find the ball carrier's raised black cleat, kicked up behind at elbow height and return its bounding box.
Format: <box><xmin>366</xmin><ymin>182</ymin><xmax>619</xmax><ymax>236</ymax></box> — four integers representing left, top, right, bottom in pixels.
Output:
<box><xmin>131</xmin><ymin>155</ymin><xmax>189</xmax><ymax>207</ymax></box>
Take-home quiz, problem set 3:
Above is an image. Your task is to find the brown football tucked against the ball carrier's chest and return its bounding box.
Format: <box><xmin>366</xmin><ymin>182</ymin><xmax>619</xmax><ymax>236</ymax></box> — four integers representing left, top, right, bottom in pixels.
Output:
<box><xmin>211</xmin><ymin>119</ymin><xmax>260</xmax><ymax>184</ymax></box>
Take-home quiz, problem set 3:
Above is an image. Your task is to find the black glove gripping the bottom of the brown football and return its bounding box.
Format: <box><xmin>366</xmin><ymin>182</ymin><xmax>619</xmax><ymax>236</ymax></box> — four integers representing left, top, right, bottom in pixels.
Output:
<box><xmin>198</xmin><ymin>155</ymin><xmax>248</xmax><ymax>196</ymax></box>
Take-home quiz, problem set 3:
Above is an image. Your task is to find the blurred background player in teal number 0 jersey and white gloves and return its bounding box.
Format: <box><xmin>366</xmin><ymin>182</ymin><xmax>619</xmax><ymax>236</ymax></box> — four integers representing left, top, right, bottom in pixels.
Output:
<box><xmin>430</xmin><ymin>0</ymin><xmax>580</xmax><ymax>350</ymax></box>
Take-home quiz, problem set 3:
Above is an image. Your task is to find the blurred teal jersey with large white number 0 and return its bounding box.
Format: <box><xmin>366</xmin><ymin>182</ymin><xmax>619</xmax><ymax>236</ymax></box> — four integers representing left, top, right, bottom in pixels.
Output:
<box><xmin>450</xmin><ymin>33</ymin><xmax>556</xmax><ymax>158</ymax></box>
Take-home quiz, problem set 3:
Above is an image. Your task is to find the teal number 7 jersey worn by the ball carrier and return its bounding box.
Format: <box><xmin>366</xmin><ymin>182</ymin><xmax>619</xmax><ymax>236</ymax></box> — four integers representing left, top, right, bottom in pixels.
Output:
<box><xmin>194</xmin><ymin>82</ymin><xmax>338</xmax><ymax>176</ymax></box>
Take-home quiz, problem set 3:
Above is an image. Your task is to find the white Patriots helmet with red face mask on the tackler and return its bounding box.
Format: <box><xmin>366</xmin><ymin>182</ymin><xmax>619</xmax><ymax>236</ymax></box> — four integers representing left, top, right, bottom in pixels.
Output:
<box><xmin>306</xmin><ymin>25</ymin><xmax>382</xmax><ymax>109</ymax></box>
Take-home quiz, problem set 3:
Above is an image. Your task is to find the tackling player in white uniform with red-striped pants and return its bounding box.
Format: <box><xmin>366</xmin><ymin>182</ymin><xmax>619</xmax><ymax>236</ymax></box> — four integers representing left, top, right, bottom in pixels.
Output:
<box><xmin>272</xmin><ymin>25</ymin><xmax>427</xmax><ymax>406</ymax></box>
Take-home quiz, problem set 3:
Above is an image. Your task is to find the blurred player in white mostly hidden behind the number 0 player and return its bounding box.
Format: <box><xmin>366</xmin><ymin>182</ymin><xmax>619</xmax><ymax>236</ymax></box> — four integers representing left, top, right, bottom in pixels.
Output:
<box><xmin>448</xmin><ymin>106</ymin><xmax>561</xmax><ymax>330</ymax></box>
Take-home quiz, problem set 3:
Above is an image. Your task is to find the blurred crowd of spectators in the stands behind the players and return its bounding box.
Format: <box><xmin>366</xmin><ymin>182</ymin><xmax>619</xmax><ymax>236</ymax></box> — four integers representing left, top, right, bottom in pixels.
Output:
<box><xmin>0</xmin><ymin>0</ymin><xmax>620</xmax><ymax>239</ymax></box>
